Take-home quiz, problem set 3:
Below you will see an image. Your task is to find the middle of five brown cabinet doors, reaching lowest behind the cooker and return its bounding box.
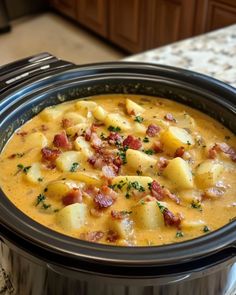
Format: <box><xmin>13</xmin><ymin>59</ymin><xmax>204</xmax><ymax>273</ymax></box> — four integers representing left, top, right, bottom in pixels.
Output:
<box><xmin>109</xmin><ymin>0</ymin><xmax>150</xmax><ymax>53</ymax></box>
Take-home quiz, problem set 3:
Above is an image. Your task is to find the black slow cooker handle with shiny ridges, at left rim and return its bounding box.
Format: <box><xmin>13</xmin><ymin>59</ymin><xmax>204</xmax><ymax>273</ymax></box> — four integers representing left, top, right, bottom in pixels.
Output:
<box><xmin>0</xmin><ymin>52</ymin><xmax>74</xmax><ymax>93</ymax></box>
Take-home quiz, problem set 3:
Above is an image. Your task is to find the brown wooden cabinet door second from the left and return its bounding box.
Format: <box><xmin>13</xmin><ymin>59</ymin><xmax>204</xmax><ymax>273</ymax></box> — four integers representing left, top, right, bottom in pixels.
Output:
<box><xmin>77</xmin><ymin>0</ymin><xmax>108</xmax><ymax>37</ymax></box>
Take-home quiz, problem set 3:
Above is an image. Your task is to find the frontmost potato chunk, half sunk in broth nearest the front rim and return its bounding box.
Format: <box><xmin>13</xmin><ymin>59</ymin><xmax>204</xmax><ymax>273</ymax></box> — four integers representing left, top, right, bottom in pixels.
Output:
<box><xmin>108</xmin><ymin>218</ymin><xmax>133</xmax><ymax>239</ymax></box>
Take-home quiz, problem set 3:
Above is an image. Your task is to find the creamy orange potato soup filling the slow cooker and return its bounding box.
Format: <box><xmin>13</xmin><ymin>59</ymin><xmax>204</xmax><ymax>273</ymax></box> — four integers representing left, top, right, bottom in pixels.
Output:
<box><xmin>0</xmin><ymin>94</ymin><xmax>236</xmax><ymax>246</ymax></box>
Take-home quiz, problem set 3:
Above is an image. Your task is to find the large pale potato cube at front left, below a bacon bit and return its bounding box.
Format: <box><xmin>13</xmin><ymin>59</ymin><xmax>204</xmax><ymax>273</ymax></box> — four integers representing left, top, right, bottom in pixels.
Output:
<box><xmin>56</xmin><ymin>203</ymin><xmax>87</xmax><ymax>230</ymax></box>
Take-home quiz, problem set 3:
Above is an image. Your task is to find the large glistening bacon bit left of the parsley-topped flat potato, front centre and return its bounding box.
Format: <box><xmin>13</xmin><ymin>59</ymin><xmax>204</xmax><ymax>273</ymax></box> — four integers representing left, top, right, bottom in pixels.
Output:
<box><xmin>94</xmin><ymin>185</ymin><xmax>117</xmax><ymax>209</ymax></box>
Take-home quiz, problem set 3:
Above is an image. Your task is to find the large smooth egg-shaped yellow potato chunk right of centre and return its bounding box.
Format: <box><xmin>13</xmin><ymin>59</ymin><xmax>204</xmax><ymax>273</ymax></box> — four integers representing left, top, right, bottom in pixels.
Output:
<box><xmin>163</xmin><ymin>157</ymin><xmax>193</xmax><ymax>189</ymax></box>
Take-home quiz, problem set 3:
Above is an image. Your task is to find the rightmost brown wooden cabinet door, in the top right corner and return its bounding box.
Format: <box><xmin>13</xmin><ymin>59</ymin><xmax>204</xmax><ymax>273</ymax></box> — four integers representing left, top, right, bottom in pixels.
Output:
<box><xmin>195</xmin><ymin>0</ymin><xmax>236</xmax><ymax>34</ymax></box>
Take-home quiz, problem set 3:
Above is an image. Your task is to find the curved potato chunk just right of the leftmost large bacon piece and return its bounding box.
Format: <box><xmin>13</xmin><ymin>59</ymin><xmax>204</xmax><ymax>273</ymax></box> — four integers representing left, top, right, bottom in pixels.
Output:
<box><xmin>56</xmin><ymin>151</ymin><xmax>85</xmax><ymax>172</ymax></box>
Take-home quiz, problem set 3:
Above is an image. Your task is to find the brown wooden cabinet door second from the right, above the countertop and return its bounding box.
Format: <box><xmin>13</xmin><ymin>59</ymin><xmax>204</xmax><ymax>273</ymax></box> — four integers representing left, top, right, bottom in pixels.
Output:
<box><xmin>148</xmin><ymin>0</ymin><xmax>196</xmax><ymax>47</ymax></box>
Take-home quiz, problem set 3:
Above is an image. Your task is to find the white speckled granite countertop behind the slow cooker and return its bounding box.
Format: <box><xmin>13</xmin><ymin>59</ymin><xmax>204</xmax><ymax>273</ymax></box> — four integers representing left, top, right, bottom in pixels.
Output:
<box><xmin>124</xmin><ymin>24</ymin><xmax>236</xmax><ymax>87</ymax></box>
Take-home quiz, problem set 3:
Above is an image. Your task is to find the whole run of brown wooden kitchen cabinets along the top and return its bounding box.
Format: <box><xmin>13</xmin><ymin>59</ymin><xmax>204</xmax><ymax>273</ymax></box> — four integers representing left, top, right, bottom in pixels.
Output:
<box><xmin>50</xmin><ymin>0</ymin><xmax>236</xmax><ymax>53</ymax></box>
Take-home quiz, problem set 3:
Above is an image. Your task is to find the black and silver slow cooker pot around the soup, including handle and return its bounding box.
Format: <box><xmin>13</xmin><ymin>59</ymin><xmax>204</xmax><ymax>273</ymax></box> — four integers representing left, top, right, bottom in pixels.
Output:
<box><xmin>0</xmin><ymin>53</ymin><xmax>236</xmax><ymax>295</ymax></box>
